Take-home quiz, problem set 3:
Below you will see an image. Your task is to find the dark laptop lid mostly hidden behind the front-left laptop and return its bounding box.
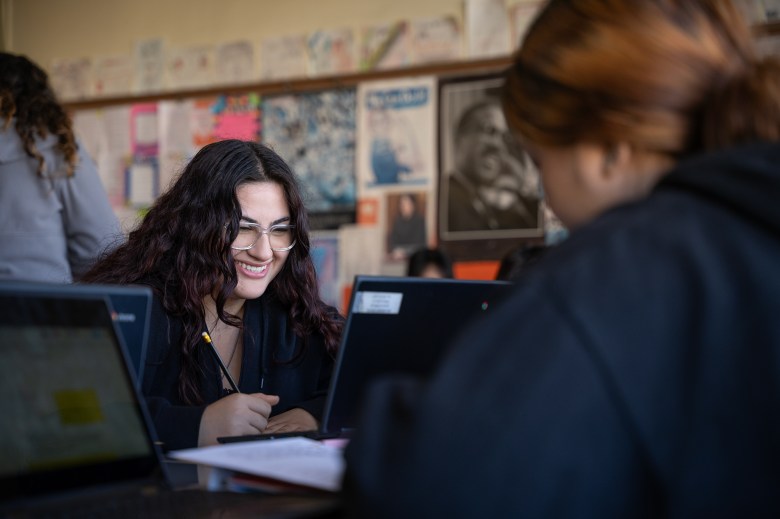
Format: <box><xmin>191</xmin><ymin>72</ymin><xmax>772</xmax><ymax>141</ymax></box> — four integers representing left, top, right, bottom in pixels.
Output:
<box><xmin>2</xmin><ymin>281</ymin><xmax>152</xmax><ymax>387</ymax></box>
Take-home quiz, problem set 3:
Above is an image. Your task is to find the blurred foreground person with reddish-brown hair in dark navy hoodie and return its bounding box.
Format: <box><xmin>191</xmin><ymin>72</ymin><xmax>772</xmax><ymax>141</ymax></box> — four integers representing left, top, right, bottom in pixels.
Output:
<box><xmin>344</xmin><ymin>0</ymin><xmax>780</xmax><ymax>518</ymax></box>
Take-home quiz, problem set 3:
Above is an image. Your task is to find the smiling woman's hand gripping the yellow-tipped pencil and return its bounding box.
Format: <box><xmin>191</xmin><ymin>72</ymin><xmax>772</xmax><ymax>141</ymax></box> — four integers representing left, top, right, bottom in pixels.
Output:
<box><xmin>198</xmin><ymin>393</ymin><xmax>280</xmax><ymax>447</ymax></box>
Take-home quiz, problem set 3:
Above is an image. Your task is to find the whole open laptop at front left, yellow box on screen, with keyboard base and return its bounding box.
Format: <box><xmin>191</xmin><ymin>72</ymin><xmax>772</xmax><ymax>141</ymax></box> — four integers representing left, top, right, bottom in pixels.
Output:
<box><xmin>0</xmin><ymin>282</ymin><xmax>336</xmax><ymax>519</ymax></box>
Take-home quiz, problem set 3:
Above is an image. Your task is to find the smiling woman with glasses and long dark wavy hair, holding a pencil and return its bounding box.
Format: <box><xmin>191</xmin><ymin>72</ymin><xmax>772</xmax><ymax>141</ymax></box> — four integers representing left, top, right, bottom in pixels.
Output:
<box><xmin>85</xmin><ymin>140</ymin><xmax>342</xmax><ymax>449</ymax></box>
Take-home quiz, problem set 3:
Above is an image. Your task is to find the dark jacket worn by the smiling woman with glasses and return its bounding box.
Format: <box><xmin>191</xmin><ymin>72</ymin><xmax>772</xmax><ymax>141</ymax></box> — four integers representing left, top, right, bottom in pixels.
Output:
<box><xmin>142</xmin><ymin>294</ymin><xmax>335</xmax><ymax>450</ymax></box>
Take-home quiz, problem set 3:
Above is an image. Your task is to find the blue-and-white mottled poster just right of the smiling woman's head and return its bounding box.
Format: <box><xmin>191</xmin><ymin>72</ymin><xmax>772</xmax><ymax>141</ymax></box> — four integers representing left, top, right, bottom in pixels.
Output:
<box><xmin>261</xmin><ymin>88</ymin><xmax>356</xmax><ymax>229</ymax></box>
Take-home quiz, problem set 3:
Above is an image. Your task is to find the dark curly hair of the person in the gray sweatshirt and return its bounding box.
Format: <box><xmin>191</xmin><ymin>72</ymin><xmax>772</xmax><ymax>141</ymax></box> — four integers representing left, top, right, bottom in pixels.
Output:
<box><xmin>0</xmin><ymin>52</ymin><xmax>78</xmax><ymax>177</ymax></box>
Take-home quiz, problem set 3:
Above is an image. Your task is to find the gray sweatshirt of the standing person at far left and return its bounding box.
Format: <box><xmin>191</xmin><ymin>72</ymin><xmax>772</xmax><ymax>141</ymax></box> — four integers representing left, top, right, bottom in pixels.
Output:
<box><xmin>0</xmin><ymin>119</ymin><xmax>121</xmax><ymax>283</ymax></box>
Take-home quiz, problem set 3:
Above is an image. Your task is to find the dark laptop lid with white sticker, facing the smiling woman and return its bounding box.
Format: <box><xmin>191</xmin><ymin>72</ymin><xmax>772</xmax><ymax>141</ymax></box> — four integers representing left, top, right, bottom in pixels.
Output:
<box><xmin>321</xmin><ymin>276</ymin><xmax>512</xmax><ymax>435</ymax></box>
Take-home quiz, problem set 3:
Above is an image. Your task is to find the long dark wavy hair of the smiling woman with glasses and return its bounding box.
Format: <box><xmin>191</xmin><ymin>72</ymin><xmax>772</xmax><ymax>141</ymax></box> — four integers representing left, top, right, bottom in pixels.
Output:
<box><xmin>83</xmin><ymin>140</ymin><xmax>342</xmax><ymax>404</ymax></box>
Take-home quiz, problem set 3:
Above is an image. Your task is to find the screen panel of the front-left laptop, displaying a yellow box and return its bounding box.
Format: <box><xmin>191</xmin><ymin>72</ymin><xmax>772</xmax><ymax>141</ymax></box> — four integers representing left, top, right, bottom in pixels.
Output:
<box><xmin>0</xmin><ymin>285</ymin><xmax>159</xmax><ymax>504</ymax></box>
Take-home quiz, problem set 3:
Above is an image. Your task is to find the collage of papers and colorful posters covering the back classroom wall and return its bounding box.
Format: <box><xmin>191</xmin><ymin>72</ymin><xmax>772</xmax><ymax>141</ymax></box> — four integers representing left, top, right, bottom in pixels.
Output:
<box><xmin>4</xmin><ymin>0</ymin><xmax>777</xmax><ymax>309</ymax></box>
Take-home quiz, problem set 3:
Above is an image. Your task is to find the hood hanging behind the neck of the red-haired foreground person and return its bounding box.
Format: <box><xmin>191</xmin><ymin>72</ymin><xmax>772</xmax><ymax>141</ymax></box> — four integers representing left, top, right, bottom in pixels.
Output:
<box><xmin>656</xmin><ymin>143</ymin><xmax>780</xmax><ymax>235</ymax></box>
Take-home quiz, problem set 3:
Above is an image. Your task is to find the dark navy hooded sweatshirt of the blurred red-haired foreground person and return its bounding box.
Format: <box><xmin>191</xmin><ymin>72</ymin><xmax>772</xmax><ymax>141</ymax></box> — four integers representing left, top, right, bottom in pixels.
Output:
<box><xmin>345</xmin><ymin>144</ymin><xmax>780</xmax><ymax>518</ymax></box>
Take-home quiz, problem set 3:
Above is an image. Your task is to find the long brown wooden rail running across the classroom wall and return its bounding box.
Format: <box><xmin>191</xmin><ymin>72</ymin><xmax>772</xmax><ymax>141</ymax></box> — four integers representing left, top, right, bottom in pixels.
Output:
<box><xmin>62</xmin><ymin>56</ymin><xmax>512</xmax><ymax>110</ymax></box>
